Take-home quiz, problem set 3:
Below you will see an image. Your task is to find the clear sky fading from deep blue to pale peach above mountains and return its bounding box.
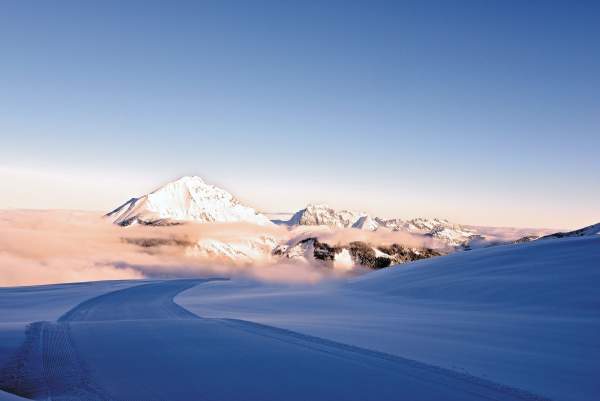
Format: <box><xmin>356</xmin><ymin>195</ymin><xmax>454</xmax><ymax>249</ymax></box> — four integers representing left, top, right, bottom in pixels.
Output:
<box><xmin>0</xmin><ymin>0</ymin><xmax>600</xmax><ymax>228</ymax></box>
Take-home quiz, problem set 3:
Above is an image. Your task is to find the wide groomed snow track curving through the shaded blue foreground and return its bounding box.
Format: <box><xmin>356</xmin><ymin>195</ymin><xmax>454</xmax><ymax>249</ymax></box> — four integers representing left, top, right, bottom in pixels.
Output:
<box><xmin>2</xmin><ymin>280</ymin><xmax>542</xmax><ymax>401</ymax></box>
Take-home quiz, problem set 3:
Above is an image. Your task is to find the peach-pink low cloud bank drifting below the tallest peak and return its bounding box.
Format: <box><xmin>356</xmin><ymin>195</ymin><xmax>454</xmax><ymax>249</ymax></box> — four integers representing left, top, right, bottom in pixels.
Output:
<box><xmin>0</xmin><ymin>210</ymin><xmax>338</xmax><ymax>286</ymax></box>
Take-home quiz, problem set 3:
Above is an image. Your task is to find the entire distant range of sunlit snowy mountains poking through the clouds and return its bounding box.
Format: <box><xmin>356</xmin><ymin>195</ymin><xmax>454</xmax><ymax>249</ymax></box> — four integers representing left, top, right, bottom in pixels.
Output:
<box><xmin>106</xmin><ymin>176</ymin><xmax>600</xmax><ymax>270</ymax></box>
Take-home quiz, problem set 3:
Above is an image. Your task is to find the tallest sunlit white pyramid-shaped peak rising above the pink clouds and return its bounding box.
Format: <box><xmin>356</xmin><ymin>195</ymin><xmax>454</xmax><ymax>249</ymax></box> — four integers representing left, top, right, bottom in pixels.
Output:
<box><xmin>106</xmin><ymin>176</ymin><xmax>271</xmax><ymax>226</ymax></box>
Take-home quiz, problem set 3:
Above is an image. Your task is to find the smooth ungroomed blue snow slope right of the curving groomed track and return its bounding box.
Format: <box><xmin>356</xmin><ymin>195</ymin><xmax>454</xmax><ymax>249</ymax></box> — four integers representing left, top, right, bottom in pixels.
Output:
<box><xmin>176</xmin><ymin>237</ymin><xmax>600</xmax><ymax>401</ymax></box>
